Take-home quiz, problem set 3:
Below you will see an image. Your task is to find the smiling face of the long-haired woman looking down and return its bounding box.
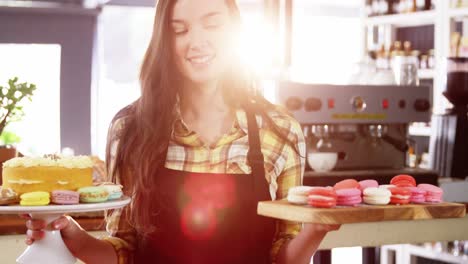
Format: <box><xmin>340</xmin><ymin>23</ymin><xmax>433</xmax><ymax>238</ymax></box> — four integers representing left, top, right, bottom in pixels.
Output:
<box><xmin>171</xmin><ymin>1</ymin><xmax>237</xmax><ymax>83</ymax></box>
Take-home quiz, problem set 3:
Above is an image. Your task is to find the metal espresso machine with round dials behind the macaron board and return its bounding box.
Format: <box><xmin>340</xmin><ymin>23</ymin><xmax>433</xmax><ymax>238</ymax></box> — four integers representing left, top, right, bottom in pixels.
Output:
<box><xmin>277</xmin><ymin>82</ymin><xmax>437</xmax><ymax>185</ymax></box>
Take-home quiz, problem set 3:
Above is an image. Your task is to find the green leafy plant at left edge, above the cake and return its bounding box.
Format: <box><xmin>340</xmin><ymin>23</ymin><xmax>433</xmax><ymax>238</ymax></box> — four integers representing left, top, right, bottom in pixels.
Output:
<box><xmin>0</xmin><ymin>77</ymin><xmax>36</xmax><ymax>143</ymax></box>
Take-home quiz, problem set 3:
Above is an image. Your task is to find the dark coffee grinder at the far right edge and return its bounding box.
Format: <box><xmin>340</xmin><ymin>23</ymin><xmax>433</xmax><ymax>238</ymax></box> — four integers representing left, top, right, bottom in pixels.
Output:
<box><xmin>430</xmin><ymin>58</ymin><xmax>468</xmax><ymax>179</ymax></box>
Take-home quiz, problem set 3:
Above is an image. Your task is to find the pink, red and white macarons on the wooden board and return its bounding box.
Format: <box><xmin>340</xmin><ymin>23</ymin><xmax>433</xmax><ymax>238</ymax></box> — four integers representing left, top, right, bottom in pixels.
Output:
<box><xmin>287</xmin><ymin>175</ymin><xmax>443</xmax><ymax>208</ymax></box>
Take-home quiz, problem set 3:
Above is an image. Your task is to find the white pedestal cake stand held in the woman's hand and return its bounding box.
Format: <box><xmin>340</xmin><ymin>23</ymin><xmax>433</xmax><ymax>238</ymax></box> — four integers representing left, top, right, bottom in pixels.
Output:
<box><xmin>0</xmin><ymin>197</ymin><xmax>131</xmax><ymax>264</ymax></box>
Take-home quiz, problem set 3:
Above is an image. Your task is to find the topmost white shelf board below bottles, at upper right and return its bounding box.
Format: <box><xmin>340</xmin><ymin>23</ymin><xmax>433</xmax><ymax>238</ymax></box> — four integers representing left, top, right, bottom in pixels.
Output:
<box><xmin>365</xmin><ymin>10</ymin><xmax>436</xmax><ymax>27</ymax></box>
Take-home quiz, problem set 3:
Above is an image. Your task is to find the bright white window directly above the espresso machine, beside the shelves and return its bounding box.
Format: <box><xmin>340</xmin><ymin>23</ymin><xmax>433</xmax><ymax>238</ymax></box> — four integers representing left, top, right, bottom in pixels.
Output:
<box><xmin>290</xmin><ymin>0</ymin><xmax>364</xmax><ymax>84</ymax></box>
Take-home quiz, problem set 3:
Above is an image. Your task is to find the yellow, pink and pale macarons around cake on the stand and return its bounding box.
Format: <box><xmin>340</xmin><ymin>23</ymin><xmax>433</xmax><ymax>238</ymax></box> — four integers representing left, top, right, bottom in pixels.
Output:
<box><xmin>0</xmin><ymin>183</ymin><xmax>123</xmax><ymax>206</ymax></box>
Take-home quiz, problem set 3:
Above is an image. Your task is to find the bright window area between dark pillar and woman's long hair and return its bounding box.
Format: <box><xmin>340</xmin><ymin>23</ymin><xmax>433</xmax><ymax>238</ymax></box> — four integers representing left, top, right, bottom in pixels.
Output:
<box><xmin>92</xmin><ymin>6</ymin><xmax>154</xmax><ymax>158</ymax></box>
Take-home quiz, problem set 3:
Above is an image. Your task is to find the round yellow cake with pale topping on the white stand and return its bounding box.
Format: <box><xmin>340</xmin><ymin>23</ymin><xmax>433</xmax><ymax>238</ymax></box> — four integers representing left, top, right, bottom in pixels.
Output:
<box><xmin>2</xmin><ymin>156</ymin><xmax>93</xmax><ymax>195</ymax></box>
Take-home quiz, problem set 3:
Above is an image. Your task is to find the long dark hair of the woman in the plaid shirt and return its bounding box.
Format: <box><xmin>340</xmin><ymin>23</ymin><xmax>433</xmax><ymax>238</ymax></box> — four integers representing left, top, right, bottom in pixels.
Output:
<box><xmin>106</xmin><ymin>0</ymin><xmax>296</xmax><ymax>234</ymax></box>
